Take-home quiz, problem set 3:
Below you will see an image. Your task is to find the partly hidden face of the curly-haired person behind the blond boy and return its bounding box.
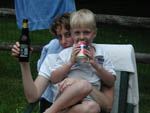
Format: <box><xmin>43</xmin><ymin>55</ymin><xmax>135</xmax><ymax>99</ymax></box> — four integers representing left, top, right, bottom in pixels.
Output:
<box><xmin>56</xmin><ymin>25</ymin><xmax>73</xmax><ymax>49</ymax></box>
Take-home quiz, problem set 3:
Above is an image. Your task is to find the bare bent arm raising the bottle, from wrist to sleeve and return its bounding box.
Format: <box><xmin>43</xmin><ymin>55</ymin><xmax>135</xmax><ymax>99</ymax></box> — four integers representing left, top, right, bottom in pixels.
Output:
<box><xmin>20</xmin><ymin>62</ymin><xmax>48</xmax><ymax>103</ymax></box>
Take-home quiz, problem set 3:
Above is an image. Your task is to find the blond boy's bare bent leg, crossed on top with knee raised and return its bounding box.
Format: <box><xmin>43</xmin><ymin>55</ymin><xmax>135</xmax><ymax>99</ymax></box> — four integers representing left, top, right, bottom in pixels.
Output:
<box><xmin>45</xmin><ymin>80</ymin><xmax>92</xmax><ymax>113</ymax></box>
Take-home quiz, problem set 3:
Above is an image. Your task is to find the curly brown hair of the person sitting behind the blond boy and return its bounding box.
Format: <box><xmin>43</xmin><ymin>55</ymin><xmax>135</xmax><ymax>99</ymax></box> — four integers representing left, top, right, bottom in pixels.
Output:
<box><xmin>50</xmin><ymin>13</ymin><xmax>70</xmax><ymax>36</ymax></box>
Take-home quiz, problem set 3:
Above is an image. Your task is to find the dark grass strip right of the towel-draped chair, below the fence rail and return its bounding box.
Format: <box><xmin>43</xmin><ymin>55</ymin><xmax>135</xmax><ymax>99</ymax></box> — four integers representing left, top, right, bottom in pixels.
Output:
<box><xmin>137</xmin><ymin>64</ymin><xmax>150</xmax><ymax>113</ymax></box>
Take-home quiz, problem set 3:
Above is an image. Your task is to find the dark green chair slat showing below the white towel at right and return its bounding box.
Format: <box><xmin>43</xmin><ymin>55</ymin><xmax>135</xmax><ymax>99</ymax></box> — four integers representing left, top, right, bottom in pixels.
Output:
<box><xmin>108</xmin><ymin>71</ymin><xmax>134</xmax><ymax>113</ymax></box>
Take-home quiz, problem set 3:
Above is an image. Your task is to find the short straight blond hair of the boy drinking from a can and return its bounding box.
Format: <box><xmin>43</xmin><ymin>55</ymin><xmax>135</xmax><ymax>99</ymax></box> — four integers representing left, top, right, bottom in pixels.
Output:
<box><xmin>70</xmin><ymin>9</ymin><xmax>96</xmax><ymax>29</ymax></box>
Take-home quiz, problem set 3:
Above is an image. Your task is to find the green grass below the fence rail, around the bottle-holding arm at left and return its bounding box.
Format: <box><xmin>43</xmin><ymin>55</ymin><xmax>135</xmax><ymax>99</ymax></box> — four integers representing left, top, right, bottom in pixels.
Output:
<box><xmin>0</xmin><ymin>51</ymin><xmax>39</xmax><ymax>113</ymax></box>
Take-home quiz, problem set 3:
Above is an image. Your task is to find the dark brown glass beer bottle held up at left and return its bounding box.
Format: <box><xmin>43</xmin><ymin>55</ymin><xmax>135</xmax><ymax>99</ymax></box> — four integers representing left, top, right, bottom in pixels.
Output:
<box><xmin>19</xmin><ymin>19</ymin><xmax>30</xmax><ymax>62</ymax></box>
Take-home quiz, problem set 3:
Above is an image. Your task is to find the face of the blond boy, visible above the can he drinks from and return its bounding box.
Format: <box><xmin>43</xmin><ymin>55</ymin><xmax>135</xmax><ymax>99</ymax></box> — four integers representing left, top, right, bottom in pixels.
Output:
<box><xmin>71</xmin><ymin>28</ymin><xmax>97</xmax><ymax>45</ymax></box>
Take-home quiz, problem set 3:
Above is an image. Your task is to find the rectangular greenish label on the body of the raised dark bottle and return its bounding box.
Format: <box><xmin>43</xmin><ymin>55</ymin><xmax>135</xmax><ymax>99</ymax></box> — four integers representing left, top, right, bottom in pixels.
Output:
<box><xmin>20</xmin><ymin>44</ymin><xmax>29</xmax><ymax>57</ymax></box>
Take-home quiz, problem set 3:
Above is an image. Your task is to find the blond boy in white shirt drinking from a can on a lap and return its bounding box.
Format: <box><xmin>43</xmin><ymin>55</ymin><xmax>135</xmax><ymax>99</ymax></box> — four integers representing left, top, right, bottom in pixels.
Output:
<box><xmin>45</xmin><ymin>9</ymin><xmax>116</xmax><ymax>113</ymax></box>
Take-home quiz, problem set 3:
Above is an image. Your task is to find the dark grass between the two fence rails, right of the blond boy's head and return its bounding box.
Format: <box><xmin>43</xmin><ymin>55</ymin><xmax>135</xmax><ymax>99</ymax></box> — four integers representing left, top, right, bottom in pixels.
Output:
<box><xmin>94</xmin><ymin>25</ymin><xmax>150</xmax><ymax>53</ymax></box>
